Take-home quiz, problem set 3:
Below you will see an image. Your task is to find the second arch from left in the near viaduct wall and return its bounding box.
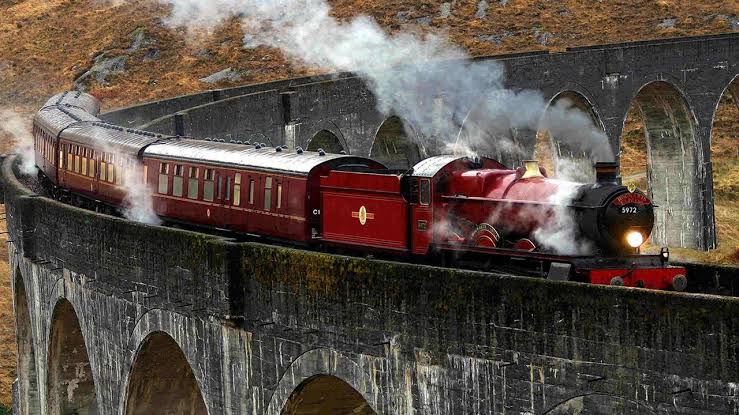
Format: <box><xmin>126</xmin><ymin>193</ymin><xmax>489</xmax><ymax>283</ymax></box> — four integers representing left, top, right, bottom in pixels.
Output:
<box><xmin>47</xmin><ymin>299</ymin><xmax>99</xmax><ymax>415</ymax></box>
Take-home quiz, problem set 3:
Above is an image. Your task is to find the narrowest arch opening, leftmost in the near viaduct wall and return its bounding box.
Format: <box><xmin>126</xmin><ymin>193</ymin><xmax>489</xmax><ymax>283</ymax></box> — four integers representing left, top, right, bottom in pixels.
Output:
<box><xmin>14</xmin><ymin>268</ymin><xmax>41</xmax><ymax>415</ymax></box>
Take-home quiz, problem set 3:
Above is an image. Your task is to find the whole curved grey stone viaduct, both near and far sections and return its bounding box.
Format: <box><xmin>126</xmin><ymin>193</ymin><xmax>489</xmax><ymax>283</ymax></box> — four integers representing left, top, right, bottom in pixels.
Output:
<box><xmin>5</xmin><ymin>35</ymin><xmax>739</xmax><ymax>415</ymax></box>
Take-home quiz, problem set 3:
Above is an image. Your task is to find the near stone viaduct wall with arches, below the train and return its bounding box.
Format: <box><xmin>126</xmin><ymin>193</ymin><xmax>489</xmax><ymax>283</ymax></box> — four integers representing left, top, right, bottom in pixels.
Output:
<box><xmin>2</xmin><ymin>145</ymin><xmax>739</xmax><ymax>415</ymax></box>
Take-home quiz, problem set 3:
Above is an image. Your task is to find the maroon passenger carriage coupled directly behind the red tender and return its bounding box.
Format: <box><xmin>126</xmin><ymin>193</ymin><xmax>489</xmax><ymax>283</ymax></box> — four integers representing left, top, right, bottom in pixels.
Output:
<box><xmin>143</xmin><ymin>138</ymin><xmax>384</xmax><ymax>243</ymax></box>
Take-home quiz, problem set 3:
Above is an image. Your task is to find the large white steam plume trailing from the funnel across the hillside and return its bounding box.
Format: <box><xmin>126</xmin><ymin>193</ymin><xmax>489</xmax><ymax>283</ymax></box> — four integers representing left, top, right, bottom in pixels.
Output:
<box><xmin>142</xmin><ymin>0</ymin><xmax>613</xmax><ymax>160</ymax></box>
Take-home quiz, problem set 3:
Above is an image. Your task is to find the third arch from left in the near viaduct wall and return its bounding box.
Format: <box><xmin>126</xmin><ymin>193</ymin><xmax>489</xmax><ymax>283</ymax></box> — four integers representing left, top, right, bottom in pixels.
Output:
<box><xmin>124</xmin><ymin>331</ymin><xmax>208</xmax><ymax>415</ymax></box>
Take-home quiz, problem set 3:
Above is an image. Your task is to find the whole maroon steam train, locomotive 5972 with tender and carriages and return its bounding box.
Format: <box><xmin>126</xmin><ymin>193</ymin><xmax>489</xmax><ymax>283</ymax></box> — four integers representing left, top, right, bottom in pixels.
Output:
<box><xmin>33</xmin><ymin>92</ymin><xmax>687</xmax><ymax>290</ymax></box>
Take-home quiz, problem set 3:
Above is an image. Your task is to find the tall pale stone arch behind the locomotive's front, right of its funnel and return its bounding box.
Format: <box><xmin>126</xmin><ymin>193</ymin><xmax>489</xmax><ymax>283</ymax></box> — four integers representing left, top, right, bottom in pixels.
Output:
<box><xmin>620</xmin><ymin>80</ymin><xmax>703</xmax><ymax>248</ymax></box>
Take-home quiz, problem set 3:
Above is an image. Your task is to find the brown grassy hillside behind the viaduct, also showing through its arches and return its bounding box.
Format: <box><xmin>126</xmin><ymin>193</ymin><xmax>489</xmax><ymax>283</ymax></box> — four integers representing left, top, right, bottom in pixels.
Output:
<box><xmin>0</xmin><ymin>0</ymin><xmax>739</xmax><ymax>404</ymax></box>
